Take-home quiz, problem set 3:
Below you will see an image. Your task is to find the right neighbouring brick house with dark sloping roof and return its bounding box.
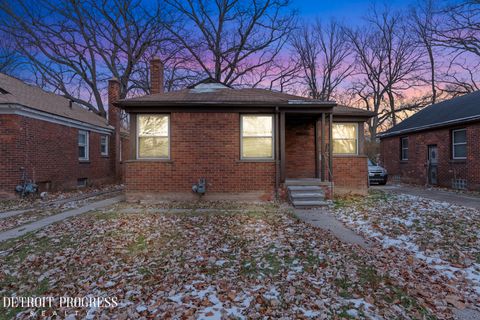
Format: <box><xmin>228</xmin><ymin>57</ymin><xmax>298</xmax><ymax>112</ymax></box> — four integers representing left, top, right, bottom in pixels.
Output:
<box><xmin>380</xmin><ymin>91</ymin><xmax>480</xmax><ymax>191</ymax></box>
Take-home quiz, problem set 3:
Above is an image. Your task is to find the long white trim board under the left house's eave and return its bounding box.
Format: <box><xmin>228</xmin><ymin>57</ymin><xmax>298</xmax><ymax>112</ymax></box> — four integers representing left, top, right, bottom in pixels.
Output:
<box><xmin>0</xmin><ymin>104</ymin><xmax>114</xmax><ymax>135</ymax></box>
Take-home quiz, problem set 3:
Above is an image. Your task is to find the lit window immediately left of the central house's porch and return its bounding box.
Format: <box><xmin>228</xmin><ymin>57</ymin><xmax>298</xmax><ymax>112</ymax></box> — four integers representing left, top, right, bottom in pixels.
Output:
<box><xmin>240</xmin><ymin>115</ymin><xmax>273</xmax><ymax>159</ymax></box>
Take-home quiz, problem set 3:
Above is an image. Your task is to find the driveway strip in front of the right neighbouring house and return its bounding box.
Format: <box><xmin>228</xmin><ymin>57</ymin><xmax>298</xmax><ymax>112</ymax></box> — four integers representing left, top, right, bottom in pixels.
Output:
<box><xmin>370</xmin><ymin>184</ymin><xmax>480</xmax><ymax>210</ymax></box>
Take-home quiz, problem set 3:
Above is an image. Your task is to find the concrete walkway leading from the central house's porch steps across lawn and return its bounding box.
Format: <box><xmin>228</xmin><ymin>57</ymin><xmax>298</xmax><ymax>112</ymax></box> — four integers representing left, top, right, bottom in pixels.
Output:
<box><xmin>295</xmin><ymin>208</ymin><xmax>370</xmax><ymax>249</ymax></box>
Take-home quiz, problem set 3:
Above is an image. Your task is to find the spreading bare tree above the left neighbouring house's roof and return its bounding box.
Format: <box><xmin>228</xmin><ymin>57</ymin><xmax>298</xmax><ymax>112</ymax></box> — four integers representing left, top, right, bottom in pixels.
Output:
<box><xmin>0</xmin><ymin>0</ymin><xmax>169</xmax><ymax>116</ymax></box>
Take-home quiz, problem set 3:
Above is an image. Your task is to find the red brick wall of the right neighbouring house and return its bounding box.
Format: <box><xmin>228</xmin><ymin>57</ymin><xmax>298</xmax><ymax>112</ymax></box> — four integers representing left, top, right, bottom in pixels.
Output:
<box><xmin>380</xmin><ymin>123</ymin><xmax>480</xmax><ymax>190</ymax></box>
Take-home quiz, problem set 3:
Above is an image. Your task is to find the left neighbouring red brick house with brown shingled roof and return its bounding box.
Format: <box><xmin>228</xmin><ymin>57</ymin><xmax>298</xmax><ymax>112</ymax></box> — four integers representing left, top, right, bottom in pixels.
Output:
<box><xmin>0</xmin><ymin>74</ymin><xmax>128</xmax><ymax>197</ymax></box>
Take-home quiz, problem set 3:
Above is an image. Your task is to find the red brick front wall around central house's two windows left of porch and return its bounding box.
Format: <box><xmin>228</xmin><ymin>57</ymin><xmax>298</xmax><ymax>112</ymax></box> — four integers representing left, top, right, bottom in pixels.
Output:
<box><xmin>126</xmin><ymin>113</ymin><xmax>275</xmax><ymax>198</ymax></box>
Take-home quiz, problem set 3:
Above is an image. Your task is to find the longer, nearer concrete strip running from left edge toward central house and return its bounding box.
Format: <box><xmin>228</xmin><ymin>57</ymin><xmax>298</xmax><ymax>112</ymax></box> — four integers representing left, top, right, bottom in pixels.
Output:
<box><xmin>0</xmin><ymin>195</ymin><xmax>124</xmax><ymax>242</ymax></box>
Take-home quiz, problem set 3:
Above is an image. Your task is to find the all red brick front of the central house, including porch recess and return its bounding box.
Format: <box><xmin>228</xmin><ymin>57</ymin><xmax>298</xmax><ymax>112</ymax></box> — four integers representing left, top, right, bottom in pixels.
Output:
<box><xmin>125</xmin><ymin>113</ymin><xmax>368</xmax><ymax>200</ymax></box>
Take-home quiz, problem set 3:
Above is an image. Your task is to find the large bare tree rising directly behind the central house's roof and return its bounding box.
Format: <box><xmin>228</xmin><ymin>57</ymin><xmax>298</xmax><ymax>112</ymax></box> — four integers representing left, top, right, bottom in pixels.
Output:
<box><xmin>164</xmin><ymin>0</ymin><xmax>295</xmax><ymax>85</ymax></box>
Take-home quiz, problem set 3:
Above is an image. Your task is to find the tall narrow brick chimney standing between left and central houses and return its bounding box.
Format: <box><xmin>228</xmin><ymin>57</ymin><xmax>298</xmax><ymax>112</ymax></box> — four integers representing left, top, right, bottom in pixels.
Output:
<box><xmin>108</xmin><ymin>78</ymin><xmax>122</xmax><ymax>180</ymax></box>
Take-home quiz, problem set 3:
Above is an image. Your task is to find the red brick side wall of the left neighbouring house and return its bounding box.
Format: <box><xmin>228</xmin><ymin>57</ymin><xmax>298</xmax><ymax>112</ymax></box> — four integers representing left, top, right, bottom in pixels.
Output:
<box><xmin>0</xmin><ymin>115</ymin><xmax>119</xmax><ymax>195</ymax></box>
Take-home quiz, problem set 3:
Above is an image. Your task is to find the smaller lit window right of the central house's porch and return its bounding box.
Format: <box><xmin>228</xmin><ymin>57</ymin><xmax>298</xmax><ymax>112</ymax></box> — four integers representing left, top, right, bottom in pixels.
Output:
<box><xmin>333</xmin><ymin>123</ymin><xmax>358</xmax><ymax>154</ymax></box>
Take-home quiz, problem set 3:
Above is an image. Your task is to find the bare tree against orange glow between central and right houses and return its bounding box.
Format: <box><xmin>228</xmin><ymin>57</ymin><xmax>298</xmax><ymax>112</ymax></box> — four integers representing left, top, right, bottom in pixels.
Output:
<box><xmin>345</xmin><ymin>5</ymin><xmax>424</xmax><ymax>140</ymax></box>
